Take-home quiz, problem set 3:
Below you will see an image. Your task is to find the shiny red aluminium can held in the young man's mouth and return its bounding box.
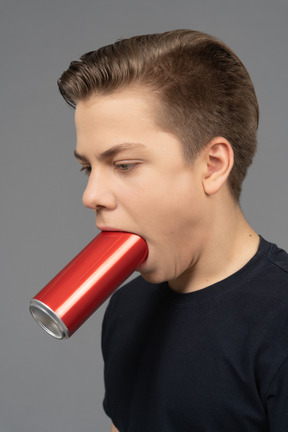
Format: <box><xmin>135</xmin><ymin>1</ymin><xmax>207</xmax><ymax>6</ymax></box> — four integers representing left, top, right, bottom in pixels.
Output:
<box><xmin>30</xmin><ymin>231</ymin><xmax>148</xmax><ymax>339</ymax></box>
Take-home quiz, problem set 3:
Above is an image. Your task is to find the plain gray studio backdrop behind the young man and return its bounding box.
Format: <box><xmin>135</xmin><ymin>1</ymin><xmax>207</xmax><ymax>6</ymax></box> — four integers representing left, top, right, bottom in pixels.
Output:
<box><xmin>0</xmin><ymin>0</ymin><xmax>288</xmax><ymax>432</ymax></box>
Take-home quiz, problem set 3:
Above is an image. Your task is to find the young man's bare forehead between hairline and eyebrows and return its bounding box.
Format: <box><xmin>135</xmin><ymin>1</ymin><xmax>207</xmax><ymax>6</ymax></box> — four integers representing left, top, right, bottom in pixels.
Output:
<box><xmin>75</xmin><ymin>87</ymin><xmax>172</xmax><ymax>158</ymax></box>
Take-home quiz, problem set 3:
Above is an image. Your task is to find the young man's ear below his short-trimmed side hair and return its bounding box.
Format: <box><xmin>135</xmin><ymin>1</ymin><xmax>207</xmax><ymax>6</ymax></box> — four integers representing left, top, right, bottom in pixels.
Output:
<box><xmin>202</xmin><ymin>137</ymin><xmax>234</xmax><ymax>195</ymax></box>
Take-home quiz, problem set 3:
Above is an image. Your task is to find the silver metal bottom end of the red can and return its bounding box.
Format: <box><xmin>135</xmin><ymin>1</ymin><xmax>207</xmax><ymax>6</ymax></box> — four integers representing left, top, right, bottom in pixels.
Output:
<box><xmin>29</xmin><ymin>299</ymin><xmax>70</xmax><ymax>339</ymax></box>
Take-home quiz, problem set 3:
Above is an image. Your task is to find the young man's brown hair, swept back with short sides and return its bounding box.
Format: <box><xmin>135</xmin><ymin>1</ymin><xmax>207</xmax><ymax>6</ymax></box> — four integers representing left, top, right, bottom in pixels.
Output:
<box><xmin>58</xmin><ymin>30</ymin><xmax>259</xmax><ymax>200</ymax></box>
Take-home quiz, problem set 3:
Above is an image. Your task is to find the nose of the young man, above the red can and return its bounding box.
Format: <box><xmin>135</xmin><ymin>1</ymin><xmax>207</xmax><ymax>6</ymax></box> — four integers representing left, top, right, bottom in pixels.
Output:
<box><xmin>82</xmin><ymin>170</ymin><xmax>116</xmax><ymax>210</ymax></box>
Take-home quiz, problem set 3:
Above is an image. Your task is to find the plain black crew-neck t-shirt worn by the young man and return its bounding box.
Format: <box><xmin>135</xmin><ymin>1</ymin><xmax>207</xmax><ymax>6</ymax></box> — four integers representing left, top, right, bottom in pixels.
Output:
<box><xmin>102</xmin><ymin>238</ymin><xmax>288</xmax><ymax>432</ymax></box>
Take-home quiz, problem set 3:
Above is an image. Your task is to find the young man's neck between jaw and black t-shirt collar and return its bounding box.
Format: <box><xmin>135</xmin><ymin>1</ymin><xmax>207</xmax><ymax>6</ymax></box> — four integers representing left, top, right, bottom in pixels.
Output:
<box><xmin>169</xmin><ymin>196</ymin><xmax>259</xmax><ymax>293</ymax></box>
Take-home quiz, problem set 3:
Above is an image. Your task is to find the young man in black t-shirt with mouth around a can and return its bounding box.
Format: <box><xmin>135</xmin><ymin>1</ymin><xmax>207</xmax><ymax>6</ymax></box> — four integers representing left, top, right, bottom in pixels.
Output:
<box><xmin>59</xmin><ymin>30</ymin><xmax>288</xmax><ymax>432</ymax></box>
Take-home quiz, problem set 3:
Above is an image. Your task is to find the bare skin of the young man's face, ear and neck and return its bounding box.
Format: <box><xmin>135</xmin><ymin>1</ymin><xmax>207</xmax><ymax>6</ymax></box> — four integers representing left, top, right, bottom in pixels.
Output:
<box><xmin>75</xmin><ymin>87</ymin><xmax>259</xmax><ymax>432</ymax></box>
